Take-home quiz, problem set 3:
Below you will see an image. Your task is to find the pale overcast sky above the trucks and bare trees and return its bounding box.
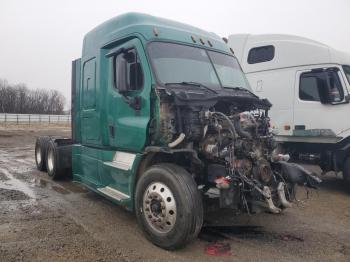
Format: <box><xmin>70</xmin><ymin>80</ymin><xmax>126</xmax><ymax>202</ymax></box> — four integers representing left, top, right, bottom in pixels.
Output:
<box><xmin>0</xmin><ymin>0</ymin><xmax>350</xmax><ymax>107</ymax></box>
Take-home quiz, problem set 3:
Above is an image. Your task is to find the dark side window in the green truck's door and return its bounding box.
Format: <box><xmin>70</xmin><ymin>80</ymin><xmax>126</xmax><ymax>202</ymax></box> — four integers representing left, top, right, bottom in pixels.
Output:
<box><xmin>114</xmin><ymin>49</ymin><xmax>143</xmax><ymax>91</ymax></box>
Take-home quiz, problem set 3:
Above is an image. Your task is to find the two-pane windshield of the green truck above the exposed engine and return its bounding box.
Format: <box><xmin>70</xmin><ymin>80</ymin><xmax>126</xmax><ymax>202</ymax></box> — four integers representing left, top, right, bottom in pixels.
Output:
<box><xmin>148</xmin><ymin>42</ymin><xmax>251</xmax><ymax>91</ymax></box>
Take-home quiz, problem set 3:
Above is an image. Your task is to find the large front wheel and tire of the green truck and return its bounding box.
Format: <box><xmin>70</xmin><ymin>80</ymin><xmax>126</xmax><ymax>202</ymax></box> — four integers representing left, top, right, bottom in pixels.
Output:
<box><xmin>135</xmin><ymin>163</ymin><xmax>203</xmax><ymax>250</ymax></box>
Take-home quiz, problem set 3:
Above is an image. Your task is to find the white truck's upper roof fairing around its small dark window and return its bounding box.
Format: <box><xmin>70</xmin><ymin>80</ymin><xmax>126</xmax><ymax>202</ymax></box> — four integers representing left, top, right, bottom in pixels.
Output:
<box><xmin>228</xmin><ymin>34</ymin><xmax>350</xmax><ymax>73</ymax></box>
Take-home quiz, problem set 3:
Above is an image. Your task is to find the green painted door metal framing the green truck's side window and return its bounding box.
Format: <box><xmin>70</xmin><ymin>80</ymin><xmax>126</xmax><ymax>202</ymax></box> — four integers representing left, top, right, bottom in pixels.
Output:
<box><xmin>106</xmin><ymin>38</ymin><xmax>152</xmax><ymax>152</ymax></box>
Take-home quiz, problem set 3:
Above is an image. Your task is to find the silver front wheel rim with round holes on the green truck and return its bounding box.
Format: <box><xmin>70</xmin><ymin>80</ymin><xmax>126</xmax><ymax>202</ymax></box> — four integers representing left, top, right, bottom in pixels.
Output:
<box><xmin>143</xmin><ymin>182</ymin><xmax>177</xmax><ymax>233</ymax></box>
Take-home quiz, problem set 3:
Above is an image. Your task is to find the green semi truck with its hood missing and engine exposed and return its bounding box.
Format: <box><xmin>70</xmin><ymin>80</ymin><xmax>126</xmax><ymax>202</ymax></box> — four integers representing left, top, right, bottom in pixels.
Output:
<box><xmin>35</xmin><ymin>13</ymin><xmax>318</xmax><ymax>249</ymax></box>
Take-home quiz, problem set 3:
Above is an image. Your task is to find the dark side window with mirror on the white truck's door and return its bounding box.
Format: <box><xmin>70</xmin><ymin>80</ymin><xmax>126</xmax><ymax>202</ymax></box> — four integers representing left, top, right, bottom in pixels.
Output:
<box><xmin>299</xmin><ymin>68</ymin><xmax>344</xmax><ymax>103</ymax></box>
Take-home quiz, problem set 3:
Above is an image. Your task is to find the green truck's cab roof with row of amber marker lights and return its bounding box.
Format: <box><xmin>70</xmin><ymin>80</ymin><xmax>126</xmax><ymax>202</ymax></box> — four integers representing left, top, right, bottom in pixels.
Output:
<box><xmin>83</xmin><ymin>13</ymin><xmax>230</xmax><ymax>56</ymax></box>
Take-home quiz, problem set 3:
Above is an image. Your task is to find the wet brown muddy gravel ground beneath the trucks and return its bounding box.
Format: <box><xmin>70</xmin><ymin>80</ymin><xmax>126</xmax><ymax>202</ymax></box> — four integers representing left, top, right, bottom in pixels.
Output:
<box><xmin>0</xmin><ymin>127</ymin><xmax>350</xmax><ymax>262</ymax></box>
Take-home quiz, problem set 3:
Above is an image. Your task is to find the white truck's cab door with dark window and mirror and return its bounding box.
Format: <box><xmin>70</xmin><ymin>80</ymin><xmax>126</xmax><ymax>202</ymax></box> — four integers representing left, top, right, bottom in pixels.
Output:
<box><xmin>293</xmin><ymin>67</ymin><xmax>350</xmax><ymax>137</ymax></box>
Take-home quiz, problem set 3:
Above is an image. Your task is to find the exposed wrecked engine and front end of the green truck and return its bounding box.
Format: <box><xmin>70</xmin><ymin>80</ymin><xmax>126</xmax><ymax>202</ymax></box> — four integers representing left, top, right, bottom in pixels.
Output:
<box><xmin>153</xmin><ymin>86</ymin><xmax>320</xmax><ymax>213</ymax></box>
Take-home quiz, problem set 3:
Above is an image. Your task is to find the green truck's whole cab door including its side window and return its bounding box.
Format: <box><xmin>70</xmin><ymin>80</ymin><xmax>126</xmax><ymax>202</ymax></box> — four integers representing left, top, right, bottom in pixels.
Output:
<box><xmin>106</xmin><ymin>38</ymin><xmax>152</xmax><ymax>152</ymax></box>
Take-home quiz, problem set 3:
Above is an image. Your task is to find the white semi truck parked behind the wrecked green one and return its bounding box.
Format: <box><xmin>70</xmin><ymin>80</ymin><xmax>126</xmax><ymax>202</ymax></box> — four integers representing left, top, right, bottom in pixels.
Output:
<box><xmin>228</xmin><ymin>34</ymin><xmax>350</xmax><ymax>182</ymax></box>
